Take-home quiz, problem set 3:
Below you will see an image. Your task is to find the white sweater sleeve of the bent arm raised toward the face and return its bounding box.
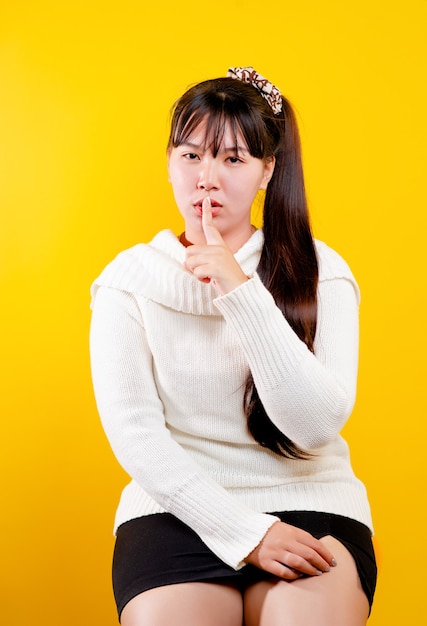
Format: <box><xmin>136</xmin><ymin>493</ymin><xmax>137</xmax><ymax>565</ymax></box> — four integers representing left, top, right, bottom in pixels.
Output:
<box><xmin>215</xmin><ymin>275</ymin><xmax>359</xmax><ymax>450</ymax></box>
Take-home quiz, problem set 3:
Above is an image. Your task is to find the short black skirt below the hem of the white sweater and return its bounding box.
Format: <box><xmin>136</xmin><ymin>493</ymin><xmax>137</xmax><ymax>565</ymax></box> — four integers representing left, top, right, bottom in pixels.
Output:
<box><xmin>113</xmin><ymin>511</ymin><xmax>377</xmax><ymax>619</ymax></box>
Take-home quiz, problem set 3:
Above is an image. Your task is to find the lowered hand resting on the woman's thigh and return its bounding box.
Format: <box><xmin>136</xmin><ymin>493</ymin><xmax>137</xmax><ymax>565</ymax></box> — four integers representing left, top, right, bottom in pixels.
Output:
<box><xmin>245</xmin><ymin>522</ymin><xmax>336</xmax><ymax>580</ymax></box>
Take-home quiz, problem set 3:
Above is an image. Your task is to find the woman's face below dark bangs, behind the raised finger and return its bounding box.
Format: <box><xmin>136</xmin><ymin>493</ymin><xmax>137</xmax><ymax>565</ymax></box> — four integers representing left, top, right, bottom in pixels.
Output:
<box><xmin>168</xmin><ymin>122</ymin><xmax>274</xmax><ymax>251</ymax></box>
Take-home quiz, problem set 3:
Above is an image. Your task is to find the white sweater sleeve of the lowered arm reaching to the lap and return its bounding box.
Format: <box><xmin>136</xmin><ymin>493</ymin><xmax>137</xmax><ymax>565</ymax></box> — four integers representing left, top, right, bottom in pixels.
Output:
<box><xmin>90</xmin><ymin>287</ymin><xmax>277</xmax><ymax>569</ymax></box>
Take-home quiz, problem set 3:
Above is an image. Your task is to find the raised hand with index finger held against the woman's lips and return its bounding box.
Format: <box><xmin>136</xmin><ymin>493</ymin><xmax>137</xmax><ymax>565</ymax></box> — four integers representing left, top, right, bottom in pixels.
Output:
<box><xmin>184</xmin><ymin>196</ymin><xmax>248</xmax><ymax>295</ymax></box>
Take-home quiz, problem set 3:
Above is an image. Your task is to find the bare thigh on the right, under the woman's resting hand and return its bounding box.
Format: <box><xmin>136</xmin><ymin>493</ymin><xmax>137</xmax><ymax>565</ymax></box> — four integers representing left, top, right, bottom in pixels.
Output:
<box><xmin>244</xmin><ymin>536</ymin><xmax>369</xmax><ymax>626</ymax></box>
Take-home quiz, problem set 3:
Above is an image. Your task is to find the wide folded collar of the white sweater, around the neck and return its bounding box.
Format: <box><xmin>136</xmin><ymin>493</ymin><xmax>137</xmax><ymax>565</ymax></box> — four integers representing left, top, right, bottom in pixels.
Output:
<box><xmin>91</xmin><ymin>230</ymin><xmax>263</xmax><ymax>316</ymax></box>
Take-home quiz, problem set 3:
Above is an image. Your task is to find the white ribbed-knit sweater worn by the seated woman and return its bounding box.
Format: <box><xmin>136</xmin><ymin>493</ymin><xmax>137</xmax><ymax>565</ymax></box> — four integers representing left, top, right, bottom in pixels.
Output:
<box><xmin>91</xmin><ymin>230</ymin><xmax>372</xmax><ymax>569</ymax></box>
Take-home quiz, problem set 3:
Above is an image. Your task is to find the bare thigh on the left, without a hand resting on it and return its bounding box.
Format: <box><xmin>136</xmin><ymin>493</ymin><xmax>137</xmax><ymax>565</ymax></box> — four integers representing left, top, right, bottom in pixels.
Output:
<box><xmin>121</xmin><ymin>583</ymin><xmax>243</xmax><ymax>626</ymax></box>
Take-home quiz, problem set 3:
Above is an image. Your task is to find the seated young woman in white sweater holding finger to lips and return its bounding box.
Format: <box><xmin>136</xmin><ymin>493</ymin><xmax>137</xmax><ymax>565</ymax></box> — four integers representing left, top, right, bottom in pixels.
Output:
<box><xmin>91</xmin><ymin>68</ymin><xmax>376</xmax><ymax>626</ymax></box>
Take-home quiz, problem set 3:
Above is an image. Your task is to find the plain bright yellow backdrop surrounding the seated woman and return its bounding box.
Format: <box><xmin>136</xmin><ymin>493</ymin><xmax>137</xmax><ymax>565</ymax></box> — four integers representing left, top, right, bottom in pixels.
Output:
<box><xmin>0</xmin><ymin>0</ymin><xmax>427</xmax><ymax>626</ymax></box>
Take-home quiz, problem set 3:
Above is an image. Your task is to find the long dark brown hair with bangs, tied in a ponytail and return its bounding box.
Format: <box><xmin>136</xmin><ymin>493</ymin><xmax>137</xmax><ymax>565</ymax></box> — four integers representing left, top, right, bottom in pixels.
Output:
<box><xmin>168</xmin><ymin>78</ymin><xmax>318</xmax><ymax>459</ymax></box>
